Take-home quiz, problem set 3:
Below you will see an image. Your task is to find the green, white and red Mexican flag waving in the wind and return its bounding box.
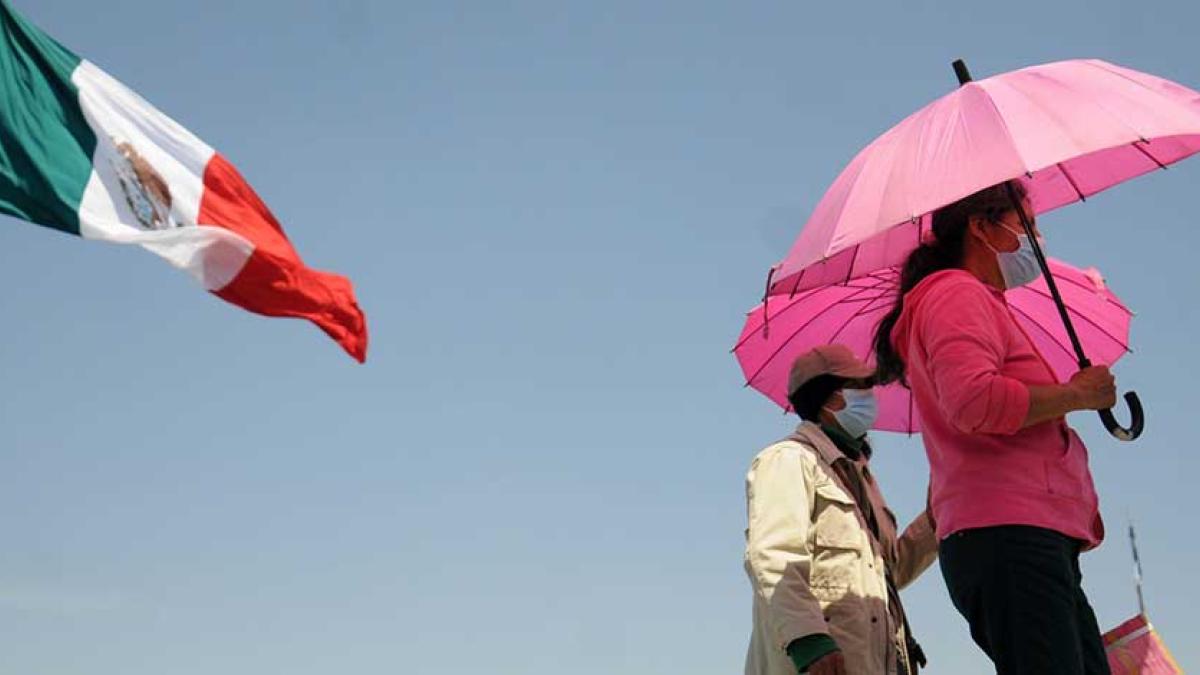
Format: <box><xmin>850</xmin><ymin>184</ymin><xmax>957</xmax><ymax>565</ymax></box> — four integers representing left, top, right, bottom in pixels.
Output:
<box><xmin>0</xmin><ymin>0</ymin><xmax>367</xmax><ymax>362</ymax></box>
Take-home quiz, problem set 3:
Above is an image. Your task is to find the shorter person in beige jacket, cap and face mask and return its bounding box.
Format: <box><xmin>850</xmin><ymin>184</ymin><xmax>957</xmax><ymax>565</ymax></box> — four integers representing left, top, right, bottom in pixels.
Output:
<box><xmin>745</xmin><ymin>345</ymin><xmax>937</xmax><ymax>675</ymax></box>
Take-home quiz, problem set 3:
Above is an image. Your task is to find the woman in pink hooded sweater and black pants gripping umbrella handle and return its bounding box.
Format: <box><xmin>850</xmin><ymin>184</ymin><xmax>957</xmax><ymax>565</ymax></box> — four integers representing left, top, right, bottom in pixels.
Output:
<box><xmin>875</xmin><ymin>184</ymin><xmax>1116</xmax><ymax>675</ymax></box>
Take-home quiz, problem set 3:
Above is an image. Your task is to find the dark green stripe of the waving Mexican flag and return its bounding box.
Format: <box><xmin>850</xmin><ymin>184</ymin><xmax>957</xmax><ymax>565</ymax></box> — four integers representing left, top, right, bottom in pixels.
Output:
<box><xmin>0</xmin><ymin>0</ymin><xmax>96</xmax><ymax>234</ymax></box>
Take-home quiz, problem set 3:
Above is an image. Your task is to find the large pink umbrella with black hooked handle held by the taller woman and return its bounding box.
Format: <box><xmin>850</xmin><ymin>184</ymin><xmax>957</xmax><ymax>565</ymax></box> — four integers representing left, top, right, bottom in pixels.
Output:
<box><xmin>767</xmin><ymin>60</ymin><xmax>1200</xmax><ymax>441</ymax></box>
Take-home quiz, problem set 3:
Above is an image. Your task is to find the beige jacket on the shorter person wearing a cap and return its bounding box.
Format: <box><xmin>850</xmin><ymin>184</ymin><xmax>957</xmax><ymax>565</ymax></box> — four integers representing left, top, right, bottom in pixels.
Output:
<box><xmin>745</xmin><ymin>422</ymin><xmax>937</xmax><ymax>675</ymax></box>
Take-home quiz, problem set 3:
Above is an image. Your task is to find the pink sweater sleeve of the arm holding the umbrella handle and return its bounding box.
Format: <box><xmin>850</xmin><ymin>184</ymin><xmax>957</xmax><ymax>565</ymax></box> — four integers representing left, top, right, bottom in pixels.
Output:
<box><xmin>918</xmin><ymin>277</ymin><xmax>1030</xmax><ymax>435</ymax></box>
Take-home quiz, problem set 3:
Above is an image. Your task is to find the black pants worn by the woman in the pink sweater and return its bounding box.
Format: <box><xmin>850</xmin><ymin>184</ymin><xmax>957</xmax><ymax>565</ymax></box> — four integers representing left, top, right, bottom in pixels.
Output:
<box><xmin>938</xmin><ymin>525</ymin><xmax>1110</xmax><ymax>675</ymax></box>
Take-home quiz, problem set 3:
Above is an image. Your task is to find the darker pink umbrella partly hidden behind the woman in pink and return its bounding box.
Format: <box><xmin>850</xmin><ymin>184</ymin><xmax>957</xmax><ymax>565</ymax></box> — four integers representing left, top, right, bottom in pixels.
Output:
<box><xmin>733</xmin><ymin>258</ymin><xmax>1133</xmax><ymax>434</ymax></box>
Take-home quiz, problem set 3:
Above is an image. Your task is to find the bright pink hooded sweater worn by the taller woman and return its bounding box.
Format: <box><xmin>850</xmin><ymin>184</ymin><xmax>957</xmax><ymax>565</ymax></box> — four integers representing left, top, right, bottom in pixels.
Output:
<box><xmin>892</xmin><ymin>270</ymin><xmax>1104</xmax><ymax>548</ymax></box>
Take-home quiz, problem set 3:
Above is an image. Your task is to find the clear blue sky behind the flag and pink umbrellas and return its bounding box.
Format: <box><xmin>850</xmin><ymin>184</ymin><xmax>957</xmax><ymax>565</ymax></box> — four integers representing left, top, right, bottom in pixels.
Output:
<box><xmin>0</xmin><ymin>0</ymin><xmax>1200</xmax><ymax>675</ymax></box>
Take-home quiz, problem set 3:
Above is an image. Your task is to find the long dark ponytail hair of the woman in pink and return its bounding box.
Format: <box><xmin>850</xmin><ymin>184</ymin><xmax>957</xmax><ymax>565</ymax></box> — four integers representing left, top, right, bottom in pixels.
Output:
<box><xmin>875</xmin><ymin>180</ymin><xmax>1026</xmax><ymax>387</ymax></box>
